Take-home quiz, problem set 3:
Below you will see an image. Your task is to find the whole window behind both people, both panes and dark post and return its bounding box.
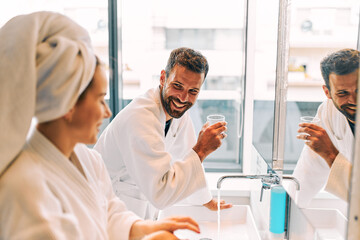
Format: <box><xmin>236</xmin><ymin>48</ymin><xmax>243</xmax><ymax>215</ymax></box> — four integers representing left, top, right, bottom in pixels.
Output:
<box><xmin>0</xmin><ymin>0</ymin><xmax>247</xmax><ymax>171</ymax></box>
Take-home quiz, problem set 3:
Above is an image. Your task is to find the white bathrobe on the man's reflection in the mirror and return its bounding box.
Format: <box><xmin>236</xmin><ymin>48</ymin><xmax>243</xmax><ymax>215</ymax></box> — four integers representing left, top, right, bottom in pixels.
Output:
<box><xmin>293</xmin><ymin>99</ymin><xmax>354</xmax><ymax>207</ymax></box>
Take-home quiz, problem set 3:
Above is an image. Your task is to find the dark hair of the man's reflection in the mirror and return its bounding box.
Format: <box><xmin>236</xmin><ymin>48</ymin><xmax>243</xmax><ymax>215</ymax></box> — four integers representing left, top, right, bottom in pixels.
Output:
<box><xmin>320</xmin><ymin>48</ymin><xmax>360</xmax><ymax>90</ymax></box>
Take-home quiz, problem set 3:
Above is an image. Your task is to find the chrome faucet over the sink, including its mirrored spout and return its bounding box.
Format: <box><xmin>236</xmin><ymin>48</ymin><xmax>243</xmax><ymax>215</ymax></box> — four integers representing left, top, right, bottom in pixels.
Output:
<box><xmin>217</xmin><ymin>173</ymin><xmax>300</xmax><ymax>202</ymax></box>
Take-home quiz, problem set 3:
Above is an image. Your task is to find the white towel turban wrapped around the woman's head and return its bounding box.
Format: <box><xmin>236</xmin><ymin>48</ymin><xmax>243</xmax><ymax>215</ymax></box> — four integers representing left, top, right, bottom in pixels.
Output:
<box><xmin>0</xmin><ymin>12</ymin><xmax>96</xmax><ymax>176</ymax></box>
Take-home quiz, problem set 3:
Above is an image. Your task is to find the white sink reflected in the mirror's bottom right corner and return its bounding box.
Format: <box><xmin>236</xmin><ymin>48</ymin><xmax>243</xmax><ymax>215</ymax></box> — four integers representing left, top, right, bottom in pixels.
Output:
<box><xmin>302</xmin><ymin>208</ymin><xmax>347</xmax><ymax>240</ymax></box>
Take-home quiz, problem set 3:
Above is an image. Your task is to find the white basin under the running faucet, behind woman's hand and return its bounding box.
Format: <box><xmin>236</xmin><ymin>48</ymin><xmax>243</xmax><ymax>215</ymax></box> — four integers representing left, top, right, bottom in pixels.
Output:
<box><xmin>159</xmin><ymin>205</ymin><xmax>261</xmax><ymax>240</ymax></box>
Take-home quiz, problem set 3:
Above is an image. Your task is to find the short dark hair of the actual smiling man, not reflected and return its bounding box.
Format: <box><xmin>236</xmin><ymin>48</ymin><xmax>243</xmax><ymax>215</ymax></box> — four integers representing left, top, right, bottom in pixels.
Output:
<box><xmin>165</xmin><ymin>47</ymin><xmax>209</xmax><ymax>79</ymax></box>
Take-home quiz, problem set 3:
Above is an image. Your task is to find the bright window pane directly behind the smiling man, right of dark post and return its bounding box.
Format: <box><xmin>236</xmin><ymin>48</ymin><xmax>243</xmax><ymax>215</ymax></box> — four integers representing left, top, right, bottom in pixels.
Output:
<box><xmin>118</xmin><ymin>0</ymin><xmax>246</xmax><ymax>171</ymax></box>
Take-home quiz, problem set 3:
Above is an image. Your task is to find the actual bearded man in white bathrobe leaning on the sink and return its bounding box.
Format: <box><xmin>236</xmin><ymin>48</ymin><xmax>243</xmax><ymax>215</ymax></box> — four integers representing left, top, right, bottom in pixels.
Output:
<box><xmin>95</xmin><ymin>48</ymin><xmax>231</xmax><ymax>219</ymax></box>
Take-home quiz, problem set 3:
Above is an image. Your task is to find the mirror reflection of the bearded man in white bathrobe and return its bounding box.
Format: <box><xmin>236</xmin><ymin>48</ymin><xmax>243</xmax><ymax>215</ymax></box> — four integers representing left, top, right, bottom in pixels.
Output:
<box><xmin>293</xmin><ymin>49</ymin><xmax>360</xmax><ymax>207</ymax></box>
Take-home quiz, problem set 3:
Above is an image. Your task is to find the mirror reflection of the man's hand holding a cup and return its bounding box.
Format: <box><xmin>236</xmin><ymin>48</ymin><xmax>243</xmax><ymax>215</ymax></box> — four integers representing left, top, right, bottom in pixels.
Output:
<box><xmin>297</xmin><ymin>123</ymin><xmax>339</xmax><ymax>167</ymax></box>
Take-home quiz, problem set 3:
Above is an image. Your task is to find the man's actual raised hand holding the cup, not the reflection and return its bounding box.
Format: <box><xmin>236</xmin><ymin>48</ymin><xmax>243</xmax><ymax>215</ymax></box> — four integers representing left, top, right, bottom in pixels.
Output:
<box><xmin>193</xmin><ymin>122</ymin><xmax>227</xmax><ymax>162</ymax></box>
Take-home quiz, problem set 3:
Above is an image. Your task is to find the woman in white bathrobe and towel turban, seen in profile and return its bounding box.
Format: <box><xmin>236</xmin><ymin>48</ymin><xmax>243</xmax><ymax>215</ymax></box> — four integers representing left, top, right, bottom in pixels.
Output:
<box><xmin>0</xmin><ymin>12</ymin><xmax>199</xmax><ymax>240</ymax></box>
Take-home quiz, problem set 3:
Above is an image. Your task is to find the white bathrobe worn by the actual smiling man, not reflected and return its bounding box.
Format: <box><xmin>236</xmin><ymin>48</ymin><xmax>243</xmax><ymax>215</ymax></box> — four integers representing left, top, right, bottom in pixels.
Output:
<box><xmin>95</xmin><ymin>87</ymin><xmax>212</xmax><ymax>218</ymax></box>
